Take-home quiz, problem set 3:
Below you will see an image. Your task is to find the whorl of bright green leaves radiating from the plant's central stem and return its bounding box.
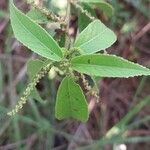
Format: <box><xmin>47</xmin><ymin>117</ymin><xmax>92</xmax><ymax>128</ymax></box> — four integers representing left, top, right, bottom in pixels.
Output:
<box><xmin>10</xmin><ymin>0</ymin><xmax>150</xmax><ymax>122</ymax></box>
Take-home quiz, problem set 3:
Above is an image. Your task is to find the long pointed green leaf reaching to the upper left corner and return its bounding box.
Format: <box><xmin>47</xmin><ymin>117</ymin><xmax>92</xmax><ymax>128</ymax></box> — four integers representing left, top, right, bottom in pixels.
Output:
<box><xmin>10</xmin><ymin>1</ymin><xmax>62</xmax><ymax>61</ymax></box>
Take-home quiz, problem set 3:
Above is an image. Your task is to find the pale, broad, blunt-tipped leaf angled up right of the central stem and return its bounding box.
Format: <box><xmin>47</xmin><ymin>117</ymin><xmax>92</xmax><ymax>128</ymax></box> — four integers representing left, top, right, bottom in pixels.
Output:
<box><xmin>74</xmin><ymin>20</ymin><xmax>116</xmax><ymax>54</ymax></box>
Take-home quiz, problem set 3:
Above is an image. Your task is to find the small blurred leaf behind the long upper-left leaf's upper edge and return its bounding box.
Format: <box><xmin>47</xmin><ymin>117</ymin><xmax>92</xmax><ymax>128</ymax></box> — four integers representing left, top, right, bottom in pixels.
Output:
<box><xmin>27</xmin><ymin>9</ymin><xmax>48</xmax><ymax>24</ymax></box>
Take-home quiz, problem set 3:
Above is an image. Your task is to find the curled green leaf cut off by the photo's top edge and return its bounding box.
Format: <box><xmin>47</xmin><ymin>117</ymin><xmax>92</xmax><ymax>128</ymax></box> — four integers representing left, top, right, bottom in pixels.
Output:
<box><xmin>80</xmin><ymin>0</ymin><xmax>114</xmax><ymax>17</ymax></box>
